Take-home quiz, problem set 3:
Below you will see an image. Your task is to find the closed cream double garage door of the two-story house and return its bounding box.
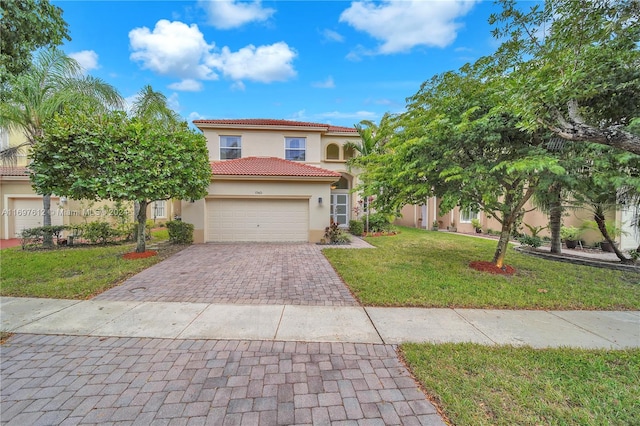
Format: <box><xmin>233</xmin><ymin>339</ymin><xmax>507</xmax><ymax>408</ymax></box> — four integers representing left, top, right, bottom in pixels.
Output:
<box><xmin>207</xmin><ymin>199</ymin><xmax>309</xmax><ymax>242</ymax></box>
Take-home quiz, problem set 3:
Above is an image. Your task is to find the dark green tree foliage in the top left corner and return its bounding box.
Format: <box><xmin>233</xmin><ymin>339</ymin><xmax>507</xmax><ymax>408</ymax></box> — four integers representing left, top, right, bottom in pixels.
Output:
<box><xmin>0</xmin><ymin>0</ymin><xmax>71</xmax><ymax>84</ymax></box>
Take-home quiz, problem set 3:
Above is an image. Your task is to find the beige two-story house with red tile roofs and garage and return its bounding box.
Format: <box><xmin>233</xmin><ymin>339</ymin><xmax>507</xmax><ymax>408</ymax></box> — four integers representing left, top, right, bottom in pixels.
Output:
<box><xmin>180</xmin><ymin>119</ymin><xmax>360</xmax><ymax>243</ymax></box>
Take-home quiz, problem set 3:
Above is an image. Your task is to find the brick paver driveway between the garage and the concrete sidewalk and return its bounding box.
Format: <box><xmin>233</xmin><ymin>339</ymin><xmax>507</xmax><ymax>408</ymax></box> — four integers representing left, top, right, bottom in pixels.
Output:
<box><xmin>96</xmin><ymin>243</ymin><xmax>358</xmax><ymax>306</ymax></box>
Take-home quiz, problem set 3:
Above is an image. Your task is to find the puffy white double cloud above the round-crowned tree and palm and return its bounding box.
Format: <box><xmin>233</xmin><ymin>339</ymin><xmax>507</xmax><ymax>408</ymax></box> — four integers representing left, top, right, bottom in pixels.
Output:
<box><xmin>129</xmin><ymin>19</ymin><xmax>297</xmax><ymax>85</ymax></box>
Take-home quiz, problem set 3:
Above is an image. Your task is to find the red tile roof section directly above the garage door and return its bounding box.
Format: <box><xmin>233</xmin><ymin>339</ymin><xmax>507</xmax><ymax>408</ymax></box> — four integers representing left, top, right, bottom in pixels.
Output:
<box><xmin>211</xmin><ymin>157</ymin><xmax>341</xmax><ymax>178</ymax></box>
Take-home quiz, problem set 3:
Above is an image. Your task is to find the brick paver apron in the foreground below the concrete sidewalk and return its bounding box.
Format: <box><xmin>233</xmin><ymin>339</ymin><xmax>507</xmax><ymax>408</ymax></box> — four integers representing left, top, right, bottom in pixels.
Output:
<box><xmin>0</xmin><ymin>334</ymin><xmax>444</xmax><ymax>426</ymax></box>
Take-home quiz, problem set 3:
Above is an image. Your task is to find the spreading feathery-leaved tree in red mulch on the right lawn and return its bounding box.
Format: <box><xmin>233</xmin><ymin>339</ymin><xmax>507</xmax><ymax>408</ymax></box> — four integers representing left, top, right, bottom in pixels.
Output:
<box><xmin>363</xmin><ymin>66</ymin><xmax>564</xmax><ymax>267</ymax></box>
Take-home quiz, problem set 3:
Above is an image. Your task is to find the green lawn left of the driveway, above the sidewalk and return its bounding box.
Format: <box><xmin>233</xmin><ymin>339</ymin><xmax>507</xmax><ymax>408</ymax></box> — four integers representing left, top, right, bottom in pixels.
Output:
<box><xmin>0</xmin><ymin>234</ymin><xmax>184</xmax><ymax>299</ymax></box>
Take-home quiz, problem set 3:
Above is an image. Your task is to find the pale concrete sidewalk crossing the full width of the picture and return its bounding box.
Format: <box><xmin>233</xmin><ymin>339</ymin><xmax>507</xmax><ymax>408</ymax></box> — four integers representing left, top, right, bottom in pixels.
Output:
<box><xmin>0</xmin><ymin>297</ymin><xmax>640</xmax><ymax>349</ymax></box>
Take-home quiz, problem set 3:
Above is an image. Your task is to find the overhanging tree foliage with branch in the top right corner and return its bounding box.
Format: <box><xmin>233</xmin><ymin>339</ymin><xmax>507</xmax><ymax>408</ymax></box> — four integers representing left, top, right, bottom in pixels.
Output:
<box><xmin>486</xmin><ymin>0</ymin><xmax>640</xmax><ymax>154</ymax></box>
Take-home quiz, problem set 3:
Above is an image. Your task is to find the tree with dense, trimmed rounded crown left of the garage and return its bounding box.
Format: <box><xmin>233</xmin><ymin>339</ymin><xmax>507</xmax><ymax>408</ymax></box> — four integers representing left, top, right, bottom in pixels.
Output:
<box><xmin>31</xmin><ymin>112</ymin><xmax>211</xmax><ymax>252</ymax></box>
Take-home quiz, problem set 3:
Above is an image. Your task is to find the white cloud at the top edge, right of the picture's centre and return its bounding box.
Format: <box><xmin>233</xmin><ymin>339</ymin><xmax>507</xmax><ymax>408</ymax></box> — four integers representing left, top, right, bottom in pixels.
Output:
<box><xmin>340</xmin><ymin>0</ymin><xmax>475</xmax><ymax>54</ymax></box>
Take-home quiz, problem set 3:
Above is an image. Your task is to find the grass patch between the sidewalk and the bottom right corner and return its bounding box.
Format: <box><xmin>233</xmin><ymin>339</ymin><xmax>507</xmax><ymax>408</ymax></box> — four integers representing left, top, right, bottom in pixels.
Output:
<box><xmin>401</xmin><ymin>343</ymin><xmax>640</xmax><ymax>426</ymax></box>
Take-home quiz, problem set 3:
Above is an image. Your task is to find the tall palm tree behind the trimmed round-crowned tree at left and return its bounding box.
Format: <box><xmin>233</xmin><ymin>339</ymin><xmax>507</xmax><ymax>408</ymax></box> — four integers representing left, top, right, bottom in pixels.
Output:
<box><xmin>0</xmin><ymin>48</ymin><xmax>123</xmax><ymax>245</ymax></box>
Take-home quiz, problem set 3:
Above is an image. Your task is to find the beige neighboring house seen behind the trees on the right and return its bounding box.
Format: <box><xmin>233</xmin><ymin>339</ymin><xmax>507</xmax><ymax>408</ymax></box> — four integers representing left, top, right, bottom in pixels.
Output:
<box><xmin>395</xmin><ymin>197</ymin><xmax>640</xmax><ymax>250</ymax></box>
